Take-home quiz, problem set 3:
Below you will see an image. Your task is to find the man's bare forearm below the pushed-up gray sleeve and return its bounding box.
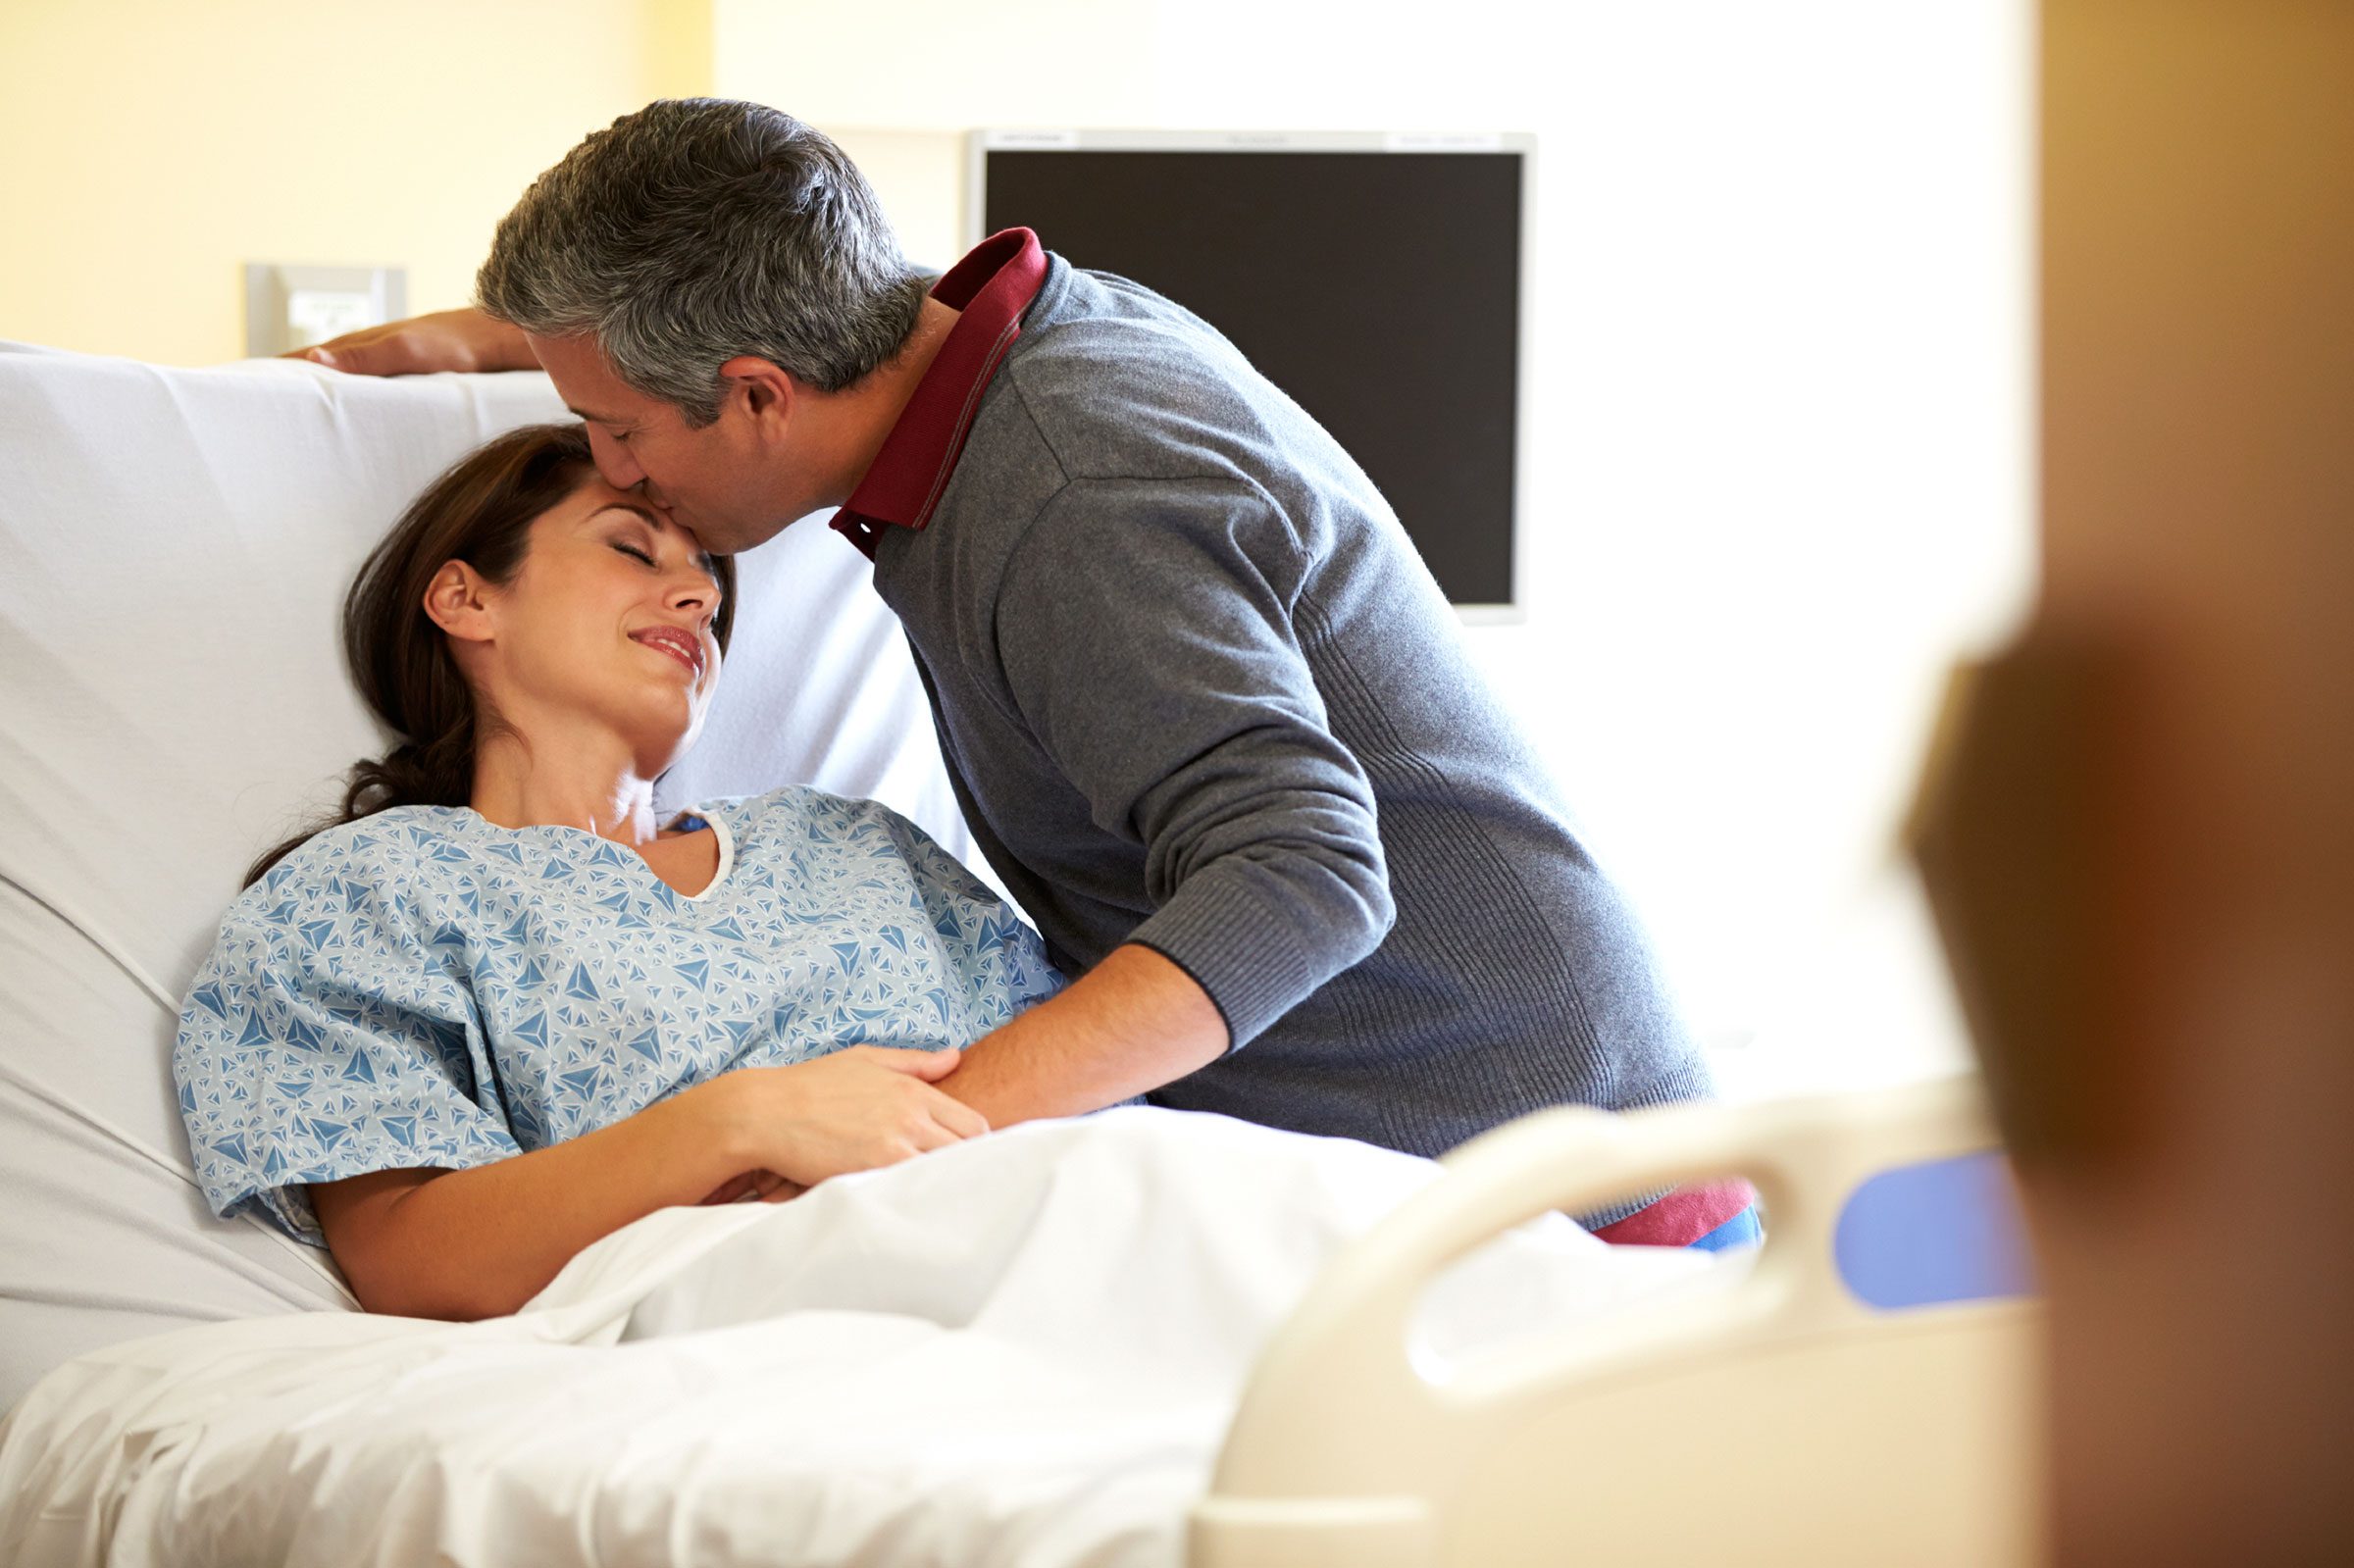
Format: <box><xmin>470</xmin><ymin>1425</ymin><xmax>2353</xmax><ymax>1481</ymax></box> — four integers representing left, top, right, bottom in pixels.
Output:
<box><xmin>937</xmin><ymin>941</ymin><xmax>1229</xmax><ymax>1128</ymax></box>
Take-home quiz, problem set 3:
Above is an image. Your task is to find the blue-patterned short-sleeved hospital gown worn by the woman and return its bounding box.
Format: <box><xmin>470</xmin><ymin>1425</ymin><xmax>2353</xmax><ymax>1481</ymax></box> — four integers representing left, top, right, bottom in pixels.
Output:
<box><xmin>172</xmin><ymin>788</ymin><xmax>1061</xmax><ymax>1245</ymax></box>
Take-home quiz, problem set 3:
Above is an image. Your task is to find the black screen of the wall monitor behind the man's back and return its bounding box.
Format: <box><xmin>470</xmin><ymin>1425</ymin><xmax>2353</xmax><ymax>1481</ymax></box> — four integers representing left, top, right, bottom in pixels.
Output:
<box><xmin>982</xmin><ymin>148</ymin><xmax>1520</xmax><ymax>605</ymax></box>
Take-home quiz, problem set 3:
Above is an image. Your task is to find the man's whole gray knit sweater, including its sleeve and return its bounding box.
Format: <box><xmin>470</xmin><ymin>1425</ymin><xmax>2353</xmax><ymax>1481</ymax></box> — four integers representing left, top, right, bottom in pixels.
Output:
<box><xmin>876</xmin><ymin>259</ymin><xmax>1709</xmax><ymax>1153</ymax></box>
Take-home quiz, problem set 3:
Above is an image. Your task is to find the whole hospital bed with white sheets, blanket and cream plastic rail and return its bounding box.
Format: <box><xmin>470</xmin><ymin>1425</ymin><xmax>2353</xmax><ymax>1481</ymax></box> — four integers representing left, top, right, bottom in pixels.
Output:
<box><xmin>0</xmin><ymin>346</ymin><xmax>2038</xmax><ymax>1568</ymax></box>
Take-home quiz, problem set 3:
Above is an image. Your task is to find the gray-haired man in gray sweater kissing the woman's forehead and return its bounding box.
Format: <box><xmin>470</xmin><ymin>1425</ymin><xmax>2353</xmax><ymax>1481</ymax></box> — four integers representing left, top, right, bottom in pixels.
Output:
<box><xmin>313</xmin><ymin>99</ymin><xmax>1756</xmax><ymax>1245</ymax></box>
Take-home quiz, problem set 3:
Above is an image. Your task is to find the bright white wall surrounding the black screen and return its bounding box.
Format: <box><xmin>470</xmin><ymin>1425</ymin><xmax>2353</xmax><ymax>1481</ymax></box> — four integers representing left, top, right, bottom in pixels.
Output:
<box><xmin>713</xmin><ymin>0</ymin><xmax>2034</xmax><ymax>1092</ymax></box>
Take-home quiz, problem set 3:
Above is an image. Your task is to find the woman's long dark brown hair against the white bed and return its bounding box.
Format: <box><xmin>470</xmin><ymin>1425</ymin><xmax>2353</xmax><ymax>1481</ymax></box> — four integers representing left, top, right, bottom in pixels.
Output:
<box><xmin>245</xmin><ymin>424</ymin><xmax>735</xmax><ymax>887</ymax></box>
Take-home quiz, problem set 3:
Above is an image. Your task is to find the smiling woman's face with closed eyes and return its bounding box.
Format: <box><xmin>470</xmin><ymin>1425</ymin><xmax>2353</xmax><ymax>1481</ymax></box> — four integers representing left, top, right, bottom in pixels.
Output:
<box><xmin>461</xmin><ymin>478</ymin><xmax>720</xmax><ymax>777</ymax></box>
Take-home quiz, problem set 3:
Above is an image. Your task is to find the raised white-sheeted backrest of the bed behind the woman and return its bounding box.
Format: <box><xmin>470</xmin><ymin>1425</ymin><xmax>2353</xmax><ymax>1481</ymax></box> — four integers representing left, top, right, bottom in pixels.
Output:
<box><xmin>0</xmin><ymin>344</ymin><xmax>972</xmax><ymax>1408</ymax></box>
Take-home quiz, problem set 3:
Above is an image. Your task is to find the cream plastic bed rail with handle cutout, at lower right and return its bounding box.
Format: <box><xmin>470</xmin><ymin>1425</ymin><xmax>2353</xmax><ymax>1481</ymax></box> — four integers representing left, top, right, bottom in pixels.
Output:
<box><xmin>1191</xmin><ymin>1081</ymin><xmax>2041</xmax><ymax>1568</ymax></box>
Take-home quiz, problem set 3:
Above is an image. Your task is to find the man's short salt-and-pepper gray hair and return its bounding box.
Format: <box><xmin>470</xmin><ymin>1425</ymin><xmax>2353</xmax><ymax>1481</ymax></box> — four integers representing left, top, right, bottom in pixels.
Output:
<box><xmin>476</xmin><ymin>99</ymin><xmax>925</xmax><ymax>427</ymax></box>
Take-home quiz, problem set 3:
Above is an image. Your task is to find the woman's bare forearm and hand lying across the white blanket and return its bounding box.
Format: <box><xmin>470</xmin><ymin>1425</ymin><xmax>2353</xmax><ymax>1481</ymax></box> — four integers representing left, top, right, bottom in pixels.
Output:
<box><xmin>311</xmin><ymin>1045</ymin><xmax>989</xmax><ymax>1321</ymax></box>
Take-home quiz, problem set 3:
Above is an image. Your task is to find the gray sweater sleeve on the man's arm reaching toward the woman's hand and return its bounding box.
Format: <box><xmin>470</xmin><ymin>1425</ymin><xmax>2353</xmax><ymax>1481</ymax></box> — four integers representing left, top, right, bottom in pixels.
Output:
<box><xmin>994</xmin><ymin>478</ymin><xmax>1396</xmax><ymax>1045</ymax></box>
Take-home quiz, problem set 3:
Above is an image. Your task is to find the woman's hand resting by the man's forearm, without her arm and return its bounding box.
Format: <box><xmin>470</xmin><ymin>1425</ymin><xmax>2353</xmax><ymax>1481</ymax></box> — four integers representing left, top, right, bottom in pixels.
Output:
<box><xmin>690</xmin><ymin>1045</ymin><xmax>989</xmax><ymax>1203</ymax></box>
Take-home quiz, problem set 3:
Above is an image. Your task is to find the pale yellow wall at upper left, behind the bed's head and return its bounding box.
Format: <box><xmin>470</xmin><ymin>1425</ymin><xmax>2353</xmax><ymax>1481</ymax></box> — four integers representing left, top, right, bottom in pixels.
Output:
<box><xmin>0</xmin><ymin>0</ymin><xmax>711</xmax><ymax>365</ymax></box>
